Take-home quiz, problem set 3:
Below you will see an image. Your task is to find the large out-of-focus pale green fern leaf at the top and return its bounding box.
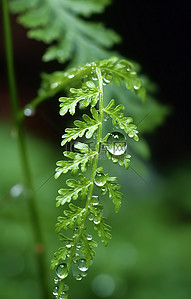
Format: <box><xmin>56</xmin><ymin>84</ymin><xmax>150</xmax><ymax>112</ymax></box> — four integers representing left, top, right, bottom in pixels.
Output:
<box><xmin>10</xmin><ymin>0</ymin><xmax>120</xmax><ymax>64</ymax></box>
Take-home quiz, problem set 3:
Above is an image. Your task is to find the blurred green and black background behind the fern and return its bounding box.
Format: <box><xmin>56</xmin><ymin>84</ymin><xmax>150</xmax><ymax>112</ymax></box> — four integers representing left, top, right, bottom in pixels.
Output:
<box><xmin>0</xmin><ymin>1</ymin><xmax>191</xmax><ymax>299</ymax></box>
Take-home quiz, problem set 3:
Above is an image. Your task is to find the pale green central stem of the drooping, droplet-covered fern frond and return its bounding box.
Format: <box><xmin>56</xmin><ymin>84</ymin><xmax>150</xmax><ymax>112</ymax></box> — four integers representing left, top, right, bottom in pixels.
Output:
<box><xmin>57</xmin><ymin>68</ymin><xmax>103</xmax><ymax>298</ymax></box>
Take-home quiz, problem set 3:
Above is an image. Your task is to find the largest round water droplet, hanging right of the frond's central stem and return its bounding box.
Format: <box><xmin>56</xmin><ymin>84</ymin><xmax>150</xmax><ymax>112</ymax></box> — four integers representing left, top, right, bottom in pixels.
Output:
<box><xmin>106</xmin><ymin>132</ymin><xmax>127</xmax><ymax>156</ymax></box>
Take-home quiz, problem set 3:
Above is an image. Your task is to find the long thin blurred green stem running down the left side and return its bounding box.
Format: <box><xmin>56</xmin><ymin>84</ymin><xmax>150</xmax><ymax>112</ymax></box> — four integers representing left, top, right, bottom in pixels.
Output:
<box><xmin>2</xmin><ymin>0</ymin><xmax>49</xmax><ymax>299</ymax></box>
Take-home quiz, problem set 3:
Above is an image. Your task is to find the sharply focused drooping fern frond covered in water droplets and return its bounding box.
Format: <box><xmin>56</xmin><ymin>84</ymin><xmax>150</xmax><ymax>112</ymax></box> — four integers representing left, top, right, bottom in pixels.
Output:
<box><xmin>51</xmin><ymin>57</ymin><xmax>144</xmax><ymax>298</ymax></box>
